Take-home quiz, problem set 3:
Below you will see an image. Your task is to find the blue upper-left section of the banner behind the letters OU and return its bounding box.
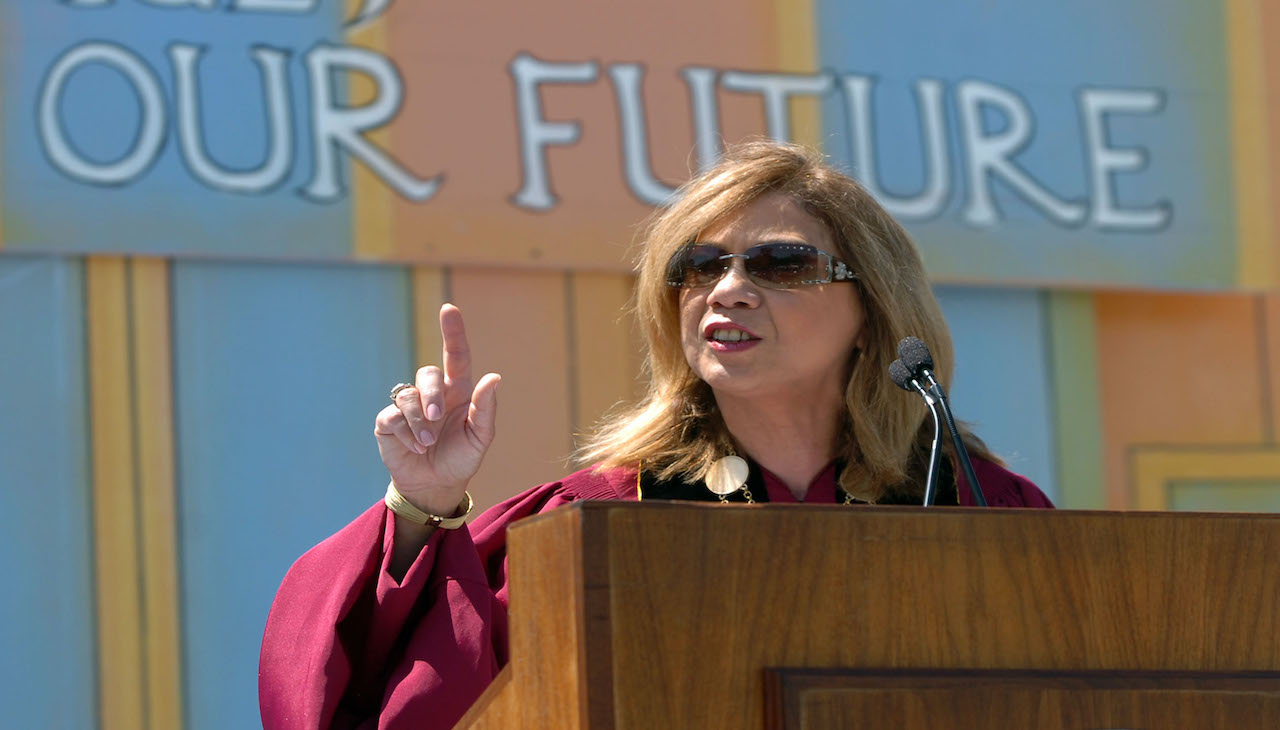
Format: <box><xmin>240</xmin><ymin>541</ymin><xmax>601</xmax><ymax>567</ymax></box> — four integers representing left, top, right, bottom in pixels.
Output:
<box><xmin>0</xmin><ymin>0</ymin><xmax>352</xmax><ymax>260</ymax></box>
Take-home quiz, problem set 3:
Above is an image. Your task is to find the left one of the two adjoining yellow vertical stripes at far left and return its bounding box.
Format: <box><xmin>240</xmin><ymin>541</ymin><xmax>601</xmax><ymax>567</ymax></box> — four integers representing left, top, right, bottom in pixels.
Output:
<box><xmin>84</xmin><ymin>256</ymin><xmax>145</xmax><ymax>730</ymax></box>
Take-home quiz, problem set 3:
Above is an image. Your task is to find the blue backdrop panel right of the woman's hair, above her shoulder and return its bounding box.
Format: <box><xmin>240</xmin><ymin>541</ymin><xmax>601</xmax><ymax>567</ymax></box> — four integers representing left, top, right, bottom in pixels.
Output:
<box><xmin>922</xmin><ymin>287</ymin><xmax>1061</xmax><ymax>503</ymax></box>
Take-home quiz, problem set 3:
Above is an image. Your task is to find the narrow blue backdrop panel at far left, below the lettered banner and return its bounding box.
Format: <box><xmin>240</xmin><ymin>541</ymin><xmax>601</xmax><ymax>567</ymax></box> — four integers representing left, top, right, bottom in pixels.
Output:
<box><xmin>0</xmin><ymin>254</ymin><xmax>97</xmax><ymax>730</ymax></box>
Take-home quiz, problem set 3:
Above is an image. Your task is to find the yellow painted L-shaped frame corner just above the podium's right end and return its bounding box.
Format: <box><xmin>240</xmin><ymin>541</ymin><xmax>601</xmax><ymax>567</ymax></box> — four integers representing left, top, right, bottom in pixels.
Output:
<box><xmin>1133</xmin><ymin>448</ymin><xmax>1280</xmax><ymax>510</ymax></box>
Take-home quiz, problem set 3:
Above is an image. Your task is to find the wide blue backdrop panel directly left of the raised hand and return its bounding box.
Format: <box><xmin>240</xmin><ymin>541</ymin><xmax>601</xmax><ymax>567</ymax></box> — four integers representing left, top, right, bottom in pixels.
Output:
<box><xmin>173</xmin><ymin>263</ymin><xmax>413</xmax><ymax>730</ymax></box>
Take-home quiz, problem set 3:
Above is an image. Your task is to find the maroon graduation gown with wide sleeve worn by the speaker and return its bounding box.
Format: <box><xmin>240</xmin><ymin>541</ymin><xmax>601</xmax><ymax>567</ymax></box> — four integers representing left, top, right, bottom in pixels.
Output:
<box><xmin>259</xmin><ymin>458</ymin><xmax>1052</xmax><ymax>730</ymax></box>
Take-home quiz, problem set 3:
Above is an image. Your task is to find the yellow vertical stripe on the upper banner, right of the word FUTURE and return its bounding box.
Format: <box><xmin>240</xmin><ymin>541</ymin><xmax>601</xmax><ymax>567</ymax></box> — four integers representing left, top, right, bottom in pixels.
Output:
<box><xmin>1225</xmin><ymin>0</ymin><xmax>1280</xmax><ymax>288</ymax></box>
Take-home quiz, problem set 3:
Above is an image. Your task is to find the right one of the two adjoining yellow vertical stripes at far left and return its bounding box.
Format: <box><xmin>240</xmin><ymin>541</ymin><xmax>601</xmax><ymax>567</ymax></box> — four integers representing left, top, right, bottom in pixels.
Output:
<box><xmin>131</xmin><ymin>259</ymin><xmax>183</xmax><ymax>730</ymax></box>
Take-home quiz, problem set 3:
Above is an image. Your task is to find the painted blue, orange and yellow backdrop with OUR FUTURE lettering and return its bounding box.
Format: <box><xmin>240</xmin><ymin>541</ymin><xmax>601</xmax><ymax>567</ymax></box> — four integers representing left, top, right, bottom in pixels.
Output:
<box><xmin>0</xmin><ymin>0</ymin><xmax>1280</xmax><ymax>730</ymax></box>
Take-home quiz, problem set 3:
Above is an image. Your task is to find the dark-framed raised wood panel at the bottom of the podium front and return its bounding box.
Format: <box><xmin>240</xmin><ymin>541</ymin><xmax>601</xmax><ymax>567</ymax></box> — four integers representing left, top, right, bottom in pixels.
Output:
<box><xmin>767</xmin><ymin>670</ymin><xmax>1280</xmax><ymax>730</ymax></box>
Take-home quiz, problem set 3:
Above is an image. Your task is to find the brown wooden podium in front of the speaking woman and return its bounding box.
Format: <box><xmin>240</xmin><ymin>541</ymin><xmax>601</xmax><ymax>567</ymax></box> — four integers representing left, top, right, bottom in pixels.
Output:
<box><xmin>458</xmin><ymin>502</ymin><xmax>1280</xmax><ymax>730</ymax></box>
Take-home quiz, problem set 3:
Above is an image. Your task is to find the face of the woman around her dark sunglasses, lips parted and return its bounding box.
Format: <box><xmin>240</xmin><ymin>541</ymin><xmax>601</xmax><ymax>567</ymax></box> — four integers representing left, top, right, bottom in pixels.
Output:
<box><xmin>680</xmin><ymin>192</ymin><xmax>867</xmax><ymax>403</ymax></box>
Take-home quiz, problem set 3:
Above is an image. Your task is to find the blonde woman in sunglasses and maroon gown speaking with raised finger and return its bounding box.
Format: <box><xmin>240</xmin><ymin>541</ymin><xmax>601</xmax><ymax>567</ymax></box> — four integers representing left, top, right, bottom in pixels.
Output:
<box><xmin>259</xmin><ymin>142</ymin><xmax>1052</xmax><ymax>729</ymax></box>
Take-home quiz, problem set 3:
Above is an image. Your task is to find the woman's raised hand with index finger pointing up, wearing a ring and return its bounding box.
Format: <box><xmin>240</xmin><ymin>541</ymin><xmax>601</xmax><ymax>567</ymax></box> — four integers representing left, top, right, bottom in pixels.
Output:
<box><xmin>374</xmin><ymin>304</ymin><xmax>502</xmax><ymax>516</ymax></box>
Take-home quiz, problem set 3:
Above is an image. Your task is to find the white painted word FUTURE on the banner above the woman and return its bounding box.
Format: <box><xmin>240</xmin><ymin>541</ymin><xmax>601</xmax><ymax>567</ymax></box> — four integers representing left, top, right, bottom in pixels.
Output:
<box><xmin>511</xmin><ymin>54</ymin><xmax>1172</xmax><ymax>231</ymax></box>
